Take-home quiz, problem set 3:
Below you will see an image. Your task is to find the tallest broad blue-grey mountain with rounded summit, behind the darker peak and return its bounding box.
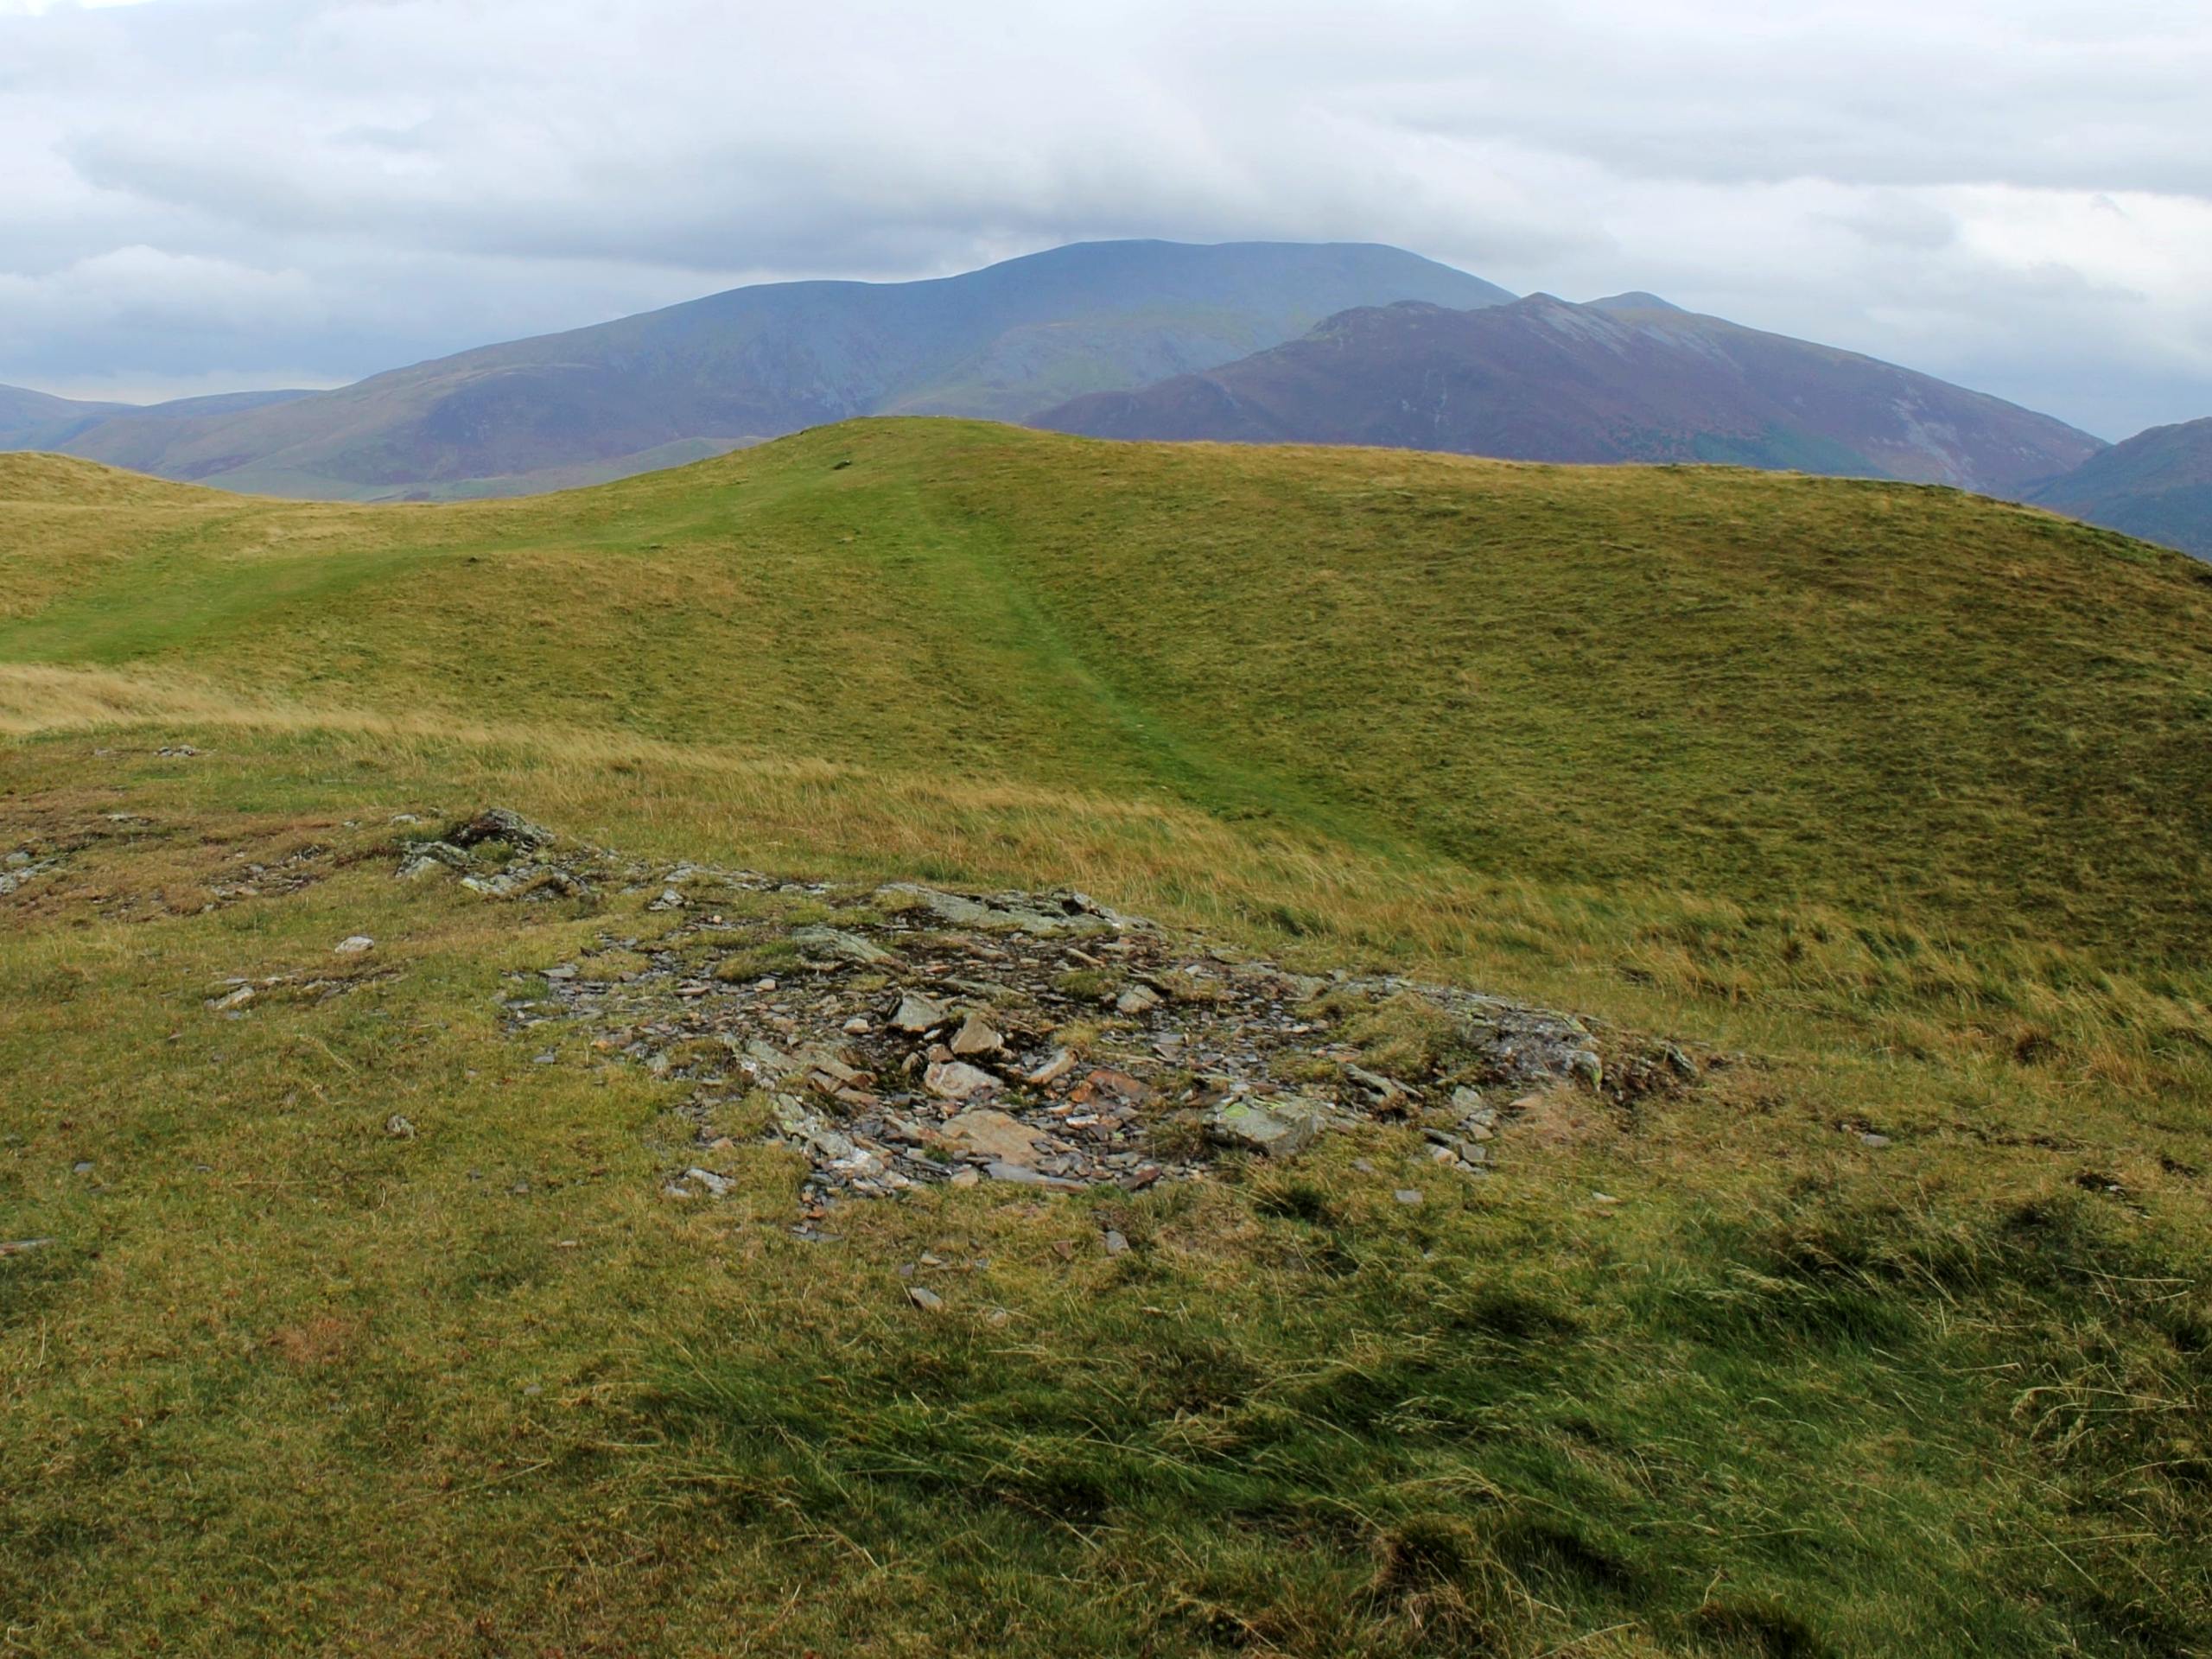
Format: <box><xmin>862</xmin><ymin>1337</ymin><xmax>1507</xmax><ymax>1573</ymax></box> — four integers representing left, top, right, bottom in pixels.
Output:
<box><xmin>42</xmin><ymin>241</ymin><xmax>1510</xmax><ymax>500</ymax></box>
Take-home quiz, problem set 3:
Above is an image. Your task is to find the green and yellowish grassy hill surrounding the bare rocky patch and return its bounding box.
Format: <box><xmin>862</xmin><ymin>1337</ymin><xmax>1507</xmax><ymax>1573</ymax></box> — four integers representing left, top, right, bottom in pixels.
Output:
<box><xmin>13</xmin><ymin>420</ymin><xmax>2212</xmax><ymax>1655</ymax></box>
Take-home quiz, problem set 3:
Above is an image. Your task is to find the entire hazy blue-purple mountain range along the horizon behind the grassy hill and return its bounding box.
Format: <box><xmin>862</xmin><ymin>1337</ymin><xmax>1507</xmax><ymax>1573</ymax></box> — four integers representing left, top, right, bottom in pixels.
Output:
<box><xmin>0</xmin><ymin>241</ymin><xmax>2212</xmax><ymax>557</ymax></box>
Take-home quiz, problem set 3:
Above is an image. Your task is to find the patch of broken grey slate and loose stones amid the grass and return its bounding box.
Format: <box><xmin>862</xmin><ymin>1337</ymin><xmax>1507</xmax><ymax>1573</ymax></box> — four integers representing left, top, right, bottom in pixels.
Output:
<box><xmin>398</xmin><ymin>812</ymin><xmax>1710</xmax><ymax>1236</ymax></box>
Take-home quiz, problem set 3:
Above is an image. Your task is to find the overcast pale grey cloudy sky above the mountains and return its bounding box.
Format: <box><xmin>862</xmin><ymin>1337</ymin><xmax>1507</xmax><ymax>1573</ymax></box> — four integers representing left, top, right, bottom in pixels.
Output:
<box><xmin>0</xmin><ymin>0</ymin><xmax>2212</xmax><ymax>438</ymax></box>
